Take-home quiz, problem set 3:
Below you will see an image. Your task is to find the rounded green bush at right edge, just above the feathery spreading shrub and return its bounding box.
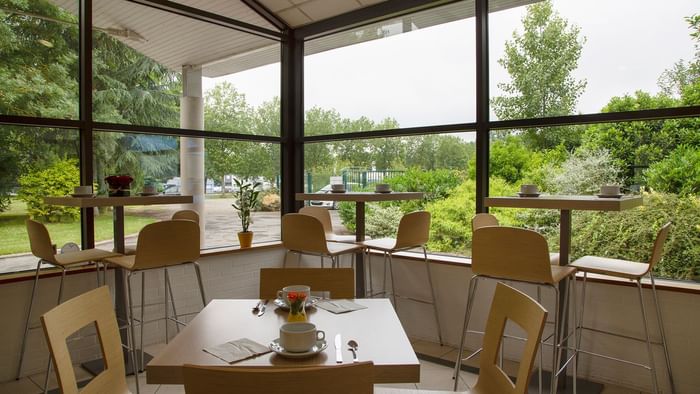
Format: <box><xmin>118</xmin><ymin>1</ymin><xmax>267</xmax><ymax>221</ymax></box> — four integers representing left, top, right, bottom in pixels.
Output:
<box><xmin>644</xmin><ymin>146</ymin><xmax>700</xmax><ymax>195</ymax></box>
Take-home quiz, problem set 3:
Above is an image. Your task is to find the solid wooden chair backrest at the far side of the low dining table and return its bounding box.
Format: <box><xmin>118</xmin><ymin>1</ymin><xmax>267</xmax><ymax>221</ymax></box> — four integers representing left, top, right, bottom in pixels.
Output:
<box><xmin>260</xmin><ymin>268</ymin><xmax>355</xmax><ymax>299</ymax></box>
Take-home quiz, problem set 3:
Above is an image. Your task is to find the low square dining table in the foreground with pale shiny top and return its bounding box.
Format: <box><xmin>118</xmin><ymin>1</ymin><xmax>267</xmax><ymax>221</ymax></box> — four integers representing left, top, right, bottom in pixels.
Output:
<box><xmin>146</xmin><ymin>299</ymin><xmax>420</xmax><ymax>384</ymax></box>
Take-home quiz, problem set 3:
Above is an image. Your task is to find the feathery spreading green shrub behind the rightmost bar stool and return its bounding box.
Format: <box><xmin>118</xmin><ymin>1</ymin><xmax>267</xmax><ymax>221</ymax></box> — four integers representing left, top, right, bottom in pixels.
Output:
<box><xmin>571</xmin><ymin>193</ymin><xmax>700</xmax><ymax>279</ymax></box>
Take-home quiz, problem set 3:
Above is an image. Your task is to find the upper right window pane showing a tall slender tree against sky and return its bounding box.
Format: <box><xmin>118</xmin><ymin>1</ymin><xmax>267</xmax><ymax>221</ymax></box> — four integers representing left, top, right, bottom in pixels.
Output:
<box><xmin>489</xmin><ymin>0</ymin><xmax>700</xmax><ymax>120</ymax></box>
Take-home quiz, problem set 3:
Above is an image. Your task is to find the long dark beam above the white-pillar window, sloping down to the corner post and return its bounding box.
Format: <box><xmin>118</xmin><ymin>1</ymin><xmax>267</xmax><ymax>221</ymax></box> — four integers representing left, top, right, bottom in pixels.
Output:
<box><xmin>128</xmin><ymin>0</ymin><xmax>283</xmax><ymax>41</ymax></box>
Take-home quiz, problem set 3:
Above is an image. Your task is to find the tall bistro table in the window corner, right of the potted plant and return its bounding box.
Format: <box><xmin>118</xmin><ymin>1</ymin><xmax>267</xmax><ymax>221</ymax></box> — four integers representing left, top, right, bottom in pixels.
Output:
<box><xmin>296</xmin><ymin>192</ymin><xmax>424</xmax><ymax>294</ymax></box>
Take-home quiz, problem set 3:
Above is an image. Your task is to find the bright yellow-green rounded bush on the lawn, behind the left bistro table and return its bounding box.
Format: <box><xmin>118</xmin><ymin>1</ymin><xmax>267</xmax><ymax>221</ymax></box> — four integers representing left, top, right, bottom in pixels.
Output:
<box><xmin>18</xmin><ymin>160</ymin><xmax>80</xmax><ymax>223</ymax></box>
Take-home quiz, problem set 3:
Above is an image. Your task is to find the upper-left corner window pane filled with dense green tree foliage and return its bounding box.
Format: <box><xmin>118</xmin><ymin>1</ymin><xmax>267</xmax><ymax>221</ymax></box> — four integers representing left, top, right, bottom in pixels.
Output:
<box><xmin>0</xmin><ymin>1</ymin><xmax>78</xmax><ymax>119</ymax></box>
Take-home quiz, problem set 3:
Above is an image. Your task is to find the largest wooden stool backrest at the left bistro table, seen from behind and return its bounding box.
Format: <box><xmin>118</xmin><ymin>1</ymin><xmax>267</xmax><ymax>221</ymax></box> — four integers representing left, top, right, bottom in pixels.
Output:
<box><xmin>133</xmin><ymin>220</ymin><xmax>200</xmax><ymax>270</ymax></box>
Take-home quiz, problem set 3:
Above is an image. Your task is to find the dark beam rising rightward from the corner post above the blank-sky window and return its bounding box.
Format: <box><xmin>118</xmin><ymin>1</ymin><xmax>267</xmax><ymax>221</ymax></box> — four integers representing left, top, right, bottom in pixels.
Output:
<box><xmin>296</xmin><ymin>0</ymin><xmax>459</xmax><ymax>40</ymax></box>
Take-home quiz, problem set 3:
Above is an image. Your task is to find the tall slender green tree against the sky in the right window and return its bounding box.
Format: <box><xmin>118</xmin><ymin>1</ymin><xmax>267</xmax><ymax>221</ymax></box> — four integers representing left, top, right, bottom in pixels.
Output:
<box><xmin>492</xmin><ymin>1</ymin><xmax>586</xmax><ymax>149</ymax></box>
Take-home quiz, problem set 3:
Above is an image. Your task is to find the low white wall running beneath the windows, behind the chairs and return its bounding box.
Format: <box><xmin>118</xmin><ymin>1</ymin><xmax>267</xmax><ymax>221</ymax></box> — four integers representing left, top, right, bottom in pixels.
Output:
<box><xmin>0</xmin><ymin>249</ymin><xmax>700</xmax><ymax>393</ymax></box>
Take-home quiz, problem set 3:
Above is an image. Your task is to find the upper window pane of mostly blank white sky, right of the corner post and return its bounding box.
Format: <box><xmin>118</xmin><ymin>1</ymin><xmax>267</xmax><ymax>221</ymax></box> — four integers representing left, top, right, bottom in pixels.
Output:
<box><xmin>304</xmin><ymin>2</ymin><xmax>475</xmax><ymax>135</ymax></box>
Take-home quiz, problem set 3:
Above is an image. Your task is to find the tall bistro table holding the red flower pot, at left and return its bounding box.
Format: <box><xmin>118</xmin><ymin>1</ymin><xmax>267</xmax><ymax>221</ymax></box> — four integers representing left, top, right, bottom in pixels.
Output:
<box><xmin>44</xmin><ymin>195</ymin><xmax>193</xmax><ymax>375</ymax></box>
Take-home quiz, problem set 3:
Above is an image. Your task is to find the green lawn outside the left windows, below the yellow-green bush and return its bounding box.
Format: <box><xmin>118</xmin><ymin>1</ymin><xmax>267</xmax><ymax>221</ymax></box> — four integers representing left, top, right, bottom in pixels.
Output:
<box><xmin>0</xmin><ymin>200</ymin><xmax>155</xmax><ymax>256</ymax></box>
